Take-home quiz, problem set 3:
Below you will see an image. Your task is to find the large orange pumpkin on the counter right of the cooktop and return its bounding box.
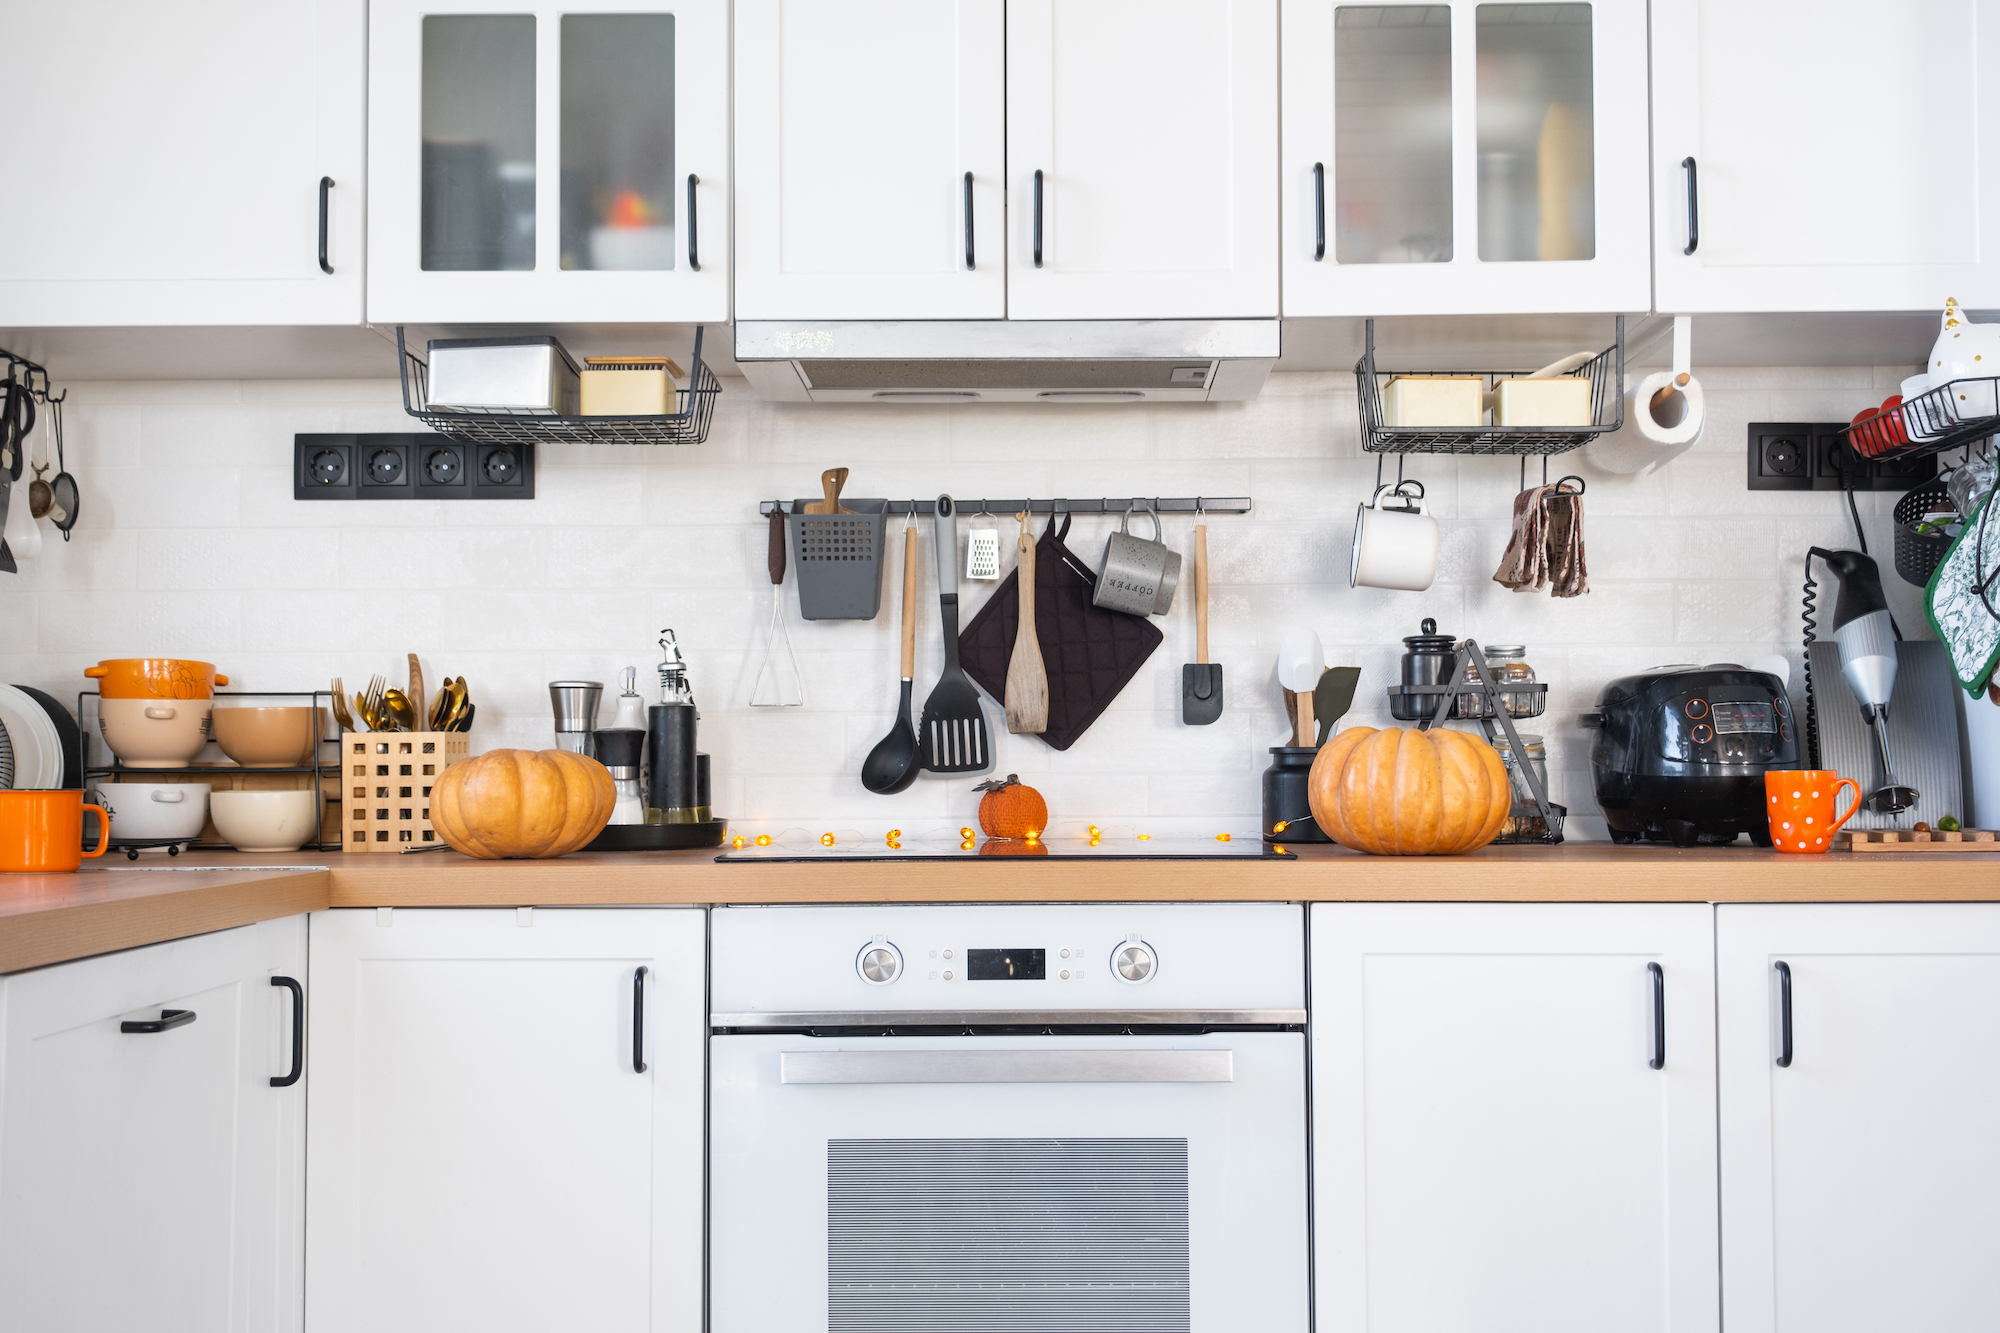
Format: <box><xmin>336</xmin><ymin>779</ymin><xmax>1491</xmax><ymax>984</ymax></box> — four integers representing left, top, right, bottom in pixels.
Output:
<box><xmin>1306</xmin><ymin>727</ymin><xmax>1512</xmax><ymax>857</ymax></box>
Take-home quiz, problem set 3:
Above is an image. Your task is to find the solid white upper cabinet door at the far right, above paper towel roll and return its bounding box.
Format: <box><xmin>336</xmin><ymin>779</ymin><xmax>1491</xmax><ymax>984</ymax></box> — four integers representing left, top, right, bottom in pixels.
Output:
<box><xmin>1652</xmin><ymin>0</ymin><xmax>2000</xmax><ymax>314</ymax></box>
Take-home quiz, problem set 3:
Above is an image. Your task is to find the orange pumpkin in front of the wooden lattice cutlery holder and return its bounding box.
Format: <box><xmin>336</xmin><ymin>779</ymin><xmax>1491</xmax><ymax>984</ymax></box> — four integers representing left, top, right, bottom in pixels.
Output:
<box><xmin>430</xmin><ymin>751</ymin><xmax>618</xmax><ymax>861</ymax></box>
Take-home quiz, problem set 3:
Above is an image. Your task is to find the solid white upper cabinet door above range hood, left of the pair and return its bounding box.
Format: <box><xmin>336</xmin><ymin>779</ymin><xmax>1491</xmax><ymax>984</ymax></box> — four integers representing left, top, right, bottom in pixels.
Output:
<box><xmin>736</xmin><ymin>0</ymin><xmax>1006</xmax><ymax>320</ymax></box>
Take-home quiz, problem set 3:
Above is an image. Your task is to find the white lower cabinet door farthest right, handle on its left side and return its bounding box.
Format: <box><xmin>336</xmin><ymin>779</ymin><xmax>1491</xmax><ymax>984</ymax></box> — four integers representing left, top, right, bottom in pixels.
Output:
<box><xmin>1716</xmin><ymin>903</ymin><xmax>2000</xmax><ymax>1333</ymax></box>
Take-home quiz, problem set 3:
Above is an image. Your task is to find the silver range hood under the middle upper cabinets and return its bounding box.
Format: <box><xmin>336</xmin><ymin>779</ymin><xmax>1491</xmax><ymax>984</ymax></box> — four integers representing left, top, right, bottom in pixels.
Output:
<box><xmin>736</xmin><ymin>320</ymin><xmax>1278</xmax><ymax>402</ymax></box>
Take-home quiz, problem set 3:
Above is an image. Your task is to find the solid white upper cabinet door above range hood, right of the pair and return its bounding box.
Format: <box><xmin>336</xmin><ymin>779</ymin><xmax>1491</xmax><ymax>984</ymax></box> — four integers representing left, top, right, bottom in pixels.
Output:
<box><xmin>1006</xmin><ymin>0</ymin><xmax>1278</xmax><ymax>320</ymax></box>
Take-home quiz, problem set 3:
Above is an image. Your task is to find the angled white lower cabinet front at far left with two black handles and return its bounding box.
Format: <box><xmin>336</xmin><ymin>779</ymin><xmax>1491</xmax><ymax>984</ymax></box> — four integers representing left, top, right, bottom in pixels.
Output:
<box><xmin>0</xmin><ymin>917</ymin><xmax>306</xmax><ymax>1333</ymax></box>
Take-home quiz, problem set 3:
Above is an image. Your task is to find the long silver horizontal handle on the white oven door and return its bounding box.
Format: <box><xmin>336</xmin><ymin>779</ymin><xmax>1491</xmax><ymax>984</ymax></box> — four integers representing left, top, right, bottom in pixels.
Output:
<box><xmin>778</xmin><ymin>1051</ymin><xmax>1236</xmax><ymax>1083</ymax></box>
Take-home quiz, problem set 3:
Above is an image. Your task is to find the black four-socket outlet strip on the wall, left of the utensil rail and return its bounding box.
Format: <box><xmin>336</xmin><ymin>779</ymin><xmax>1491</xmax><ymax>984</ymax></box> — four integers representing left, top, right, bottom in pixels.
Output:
<box><xmin>292</xmin><ymin>430</ymin><xmax>534</xmax><ymax>500</ymax></box>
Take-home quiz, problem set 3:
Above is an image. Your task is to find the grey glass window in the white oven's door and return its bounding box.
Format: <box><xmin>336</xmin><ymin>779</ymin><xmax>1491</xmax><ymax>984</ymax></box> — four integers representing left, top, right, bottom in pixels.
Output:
<box><xmin>826</xmin><ymin>1139</ymin><xmax>1188</xmax><ymax>1333</ymax></box>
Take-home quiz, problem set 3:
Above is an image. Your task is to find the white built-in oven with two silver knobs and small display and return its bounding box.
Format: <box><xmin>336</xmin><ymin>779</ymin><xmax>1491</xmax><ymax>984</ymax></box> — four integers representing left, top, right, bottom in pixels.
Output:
<box><xmin>710</xmin><ymin>903</ymin><xmax>1308</xmax><ymax>1333</ymax></box>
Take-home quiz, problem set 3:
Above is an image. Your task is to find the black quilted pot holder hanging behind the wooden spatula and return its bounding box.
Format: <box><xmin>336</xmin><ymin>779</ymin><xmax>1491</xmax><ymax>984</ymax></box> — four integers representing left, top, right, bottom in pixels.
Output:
<box><xmin>958</xmin><ymin>514</ymin><xmax>1160</xmax><ymax>751</ymax></box>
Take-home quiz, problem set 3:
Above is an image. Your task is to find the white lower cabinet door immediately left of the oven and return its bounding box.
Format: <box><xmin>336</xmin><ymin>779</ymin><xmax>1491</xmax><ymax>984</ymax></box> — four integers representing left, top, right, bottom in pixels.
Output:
<box><xmin>306</xmin><ymin>909</ymin><xmax>706</xmax><ymax>1333</ymax></box>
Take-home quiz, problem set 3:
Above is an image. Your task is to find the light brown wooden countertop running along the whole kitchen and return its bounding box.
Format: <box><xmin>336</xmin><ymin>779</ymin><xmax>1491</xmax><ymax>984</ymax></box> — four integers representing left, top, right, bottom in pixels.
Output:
<box><xmin>0</xmin><ymin>843</ymin><xmax>2000</xmax><ymax>973</ymax></box>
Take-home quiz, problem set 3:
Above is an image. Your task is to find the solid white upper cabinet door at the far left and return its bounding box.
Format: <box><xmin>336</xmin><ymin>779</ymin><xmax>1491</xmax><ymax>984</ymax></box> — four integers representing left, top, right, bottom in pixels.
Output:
<box><xmin>0</xmin><ymin>0</ymin><xmax>366</xmax><ymax>328</ymax></box>
